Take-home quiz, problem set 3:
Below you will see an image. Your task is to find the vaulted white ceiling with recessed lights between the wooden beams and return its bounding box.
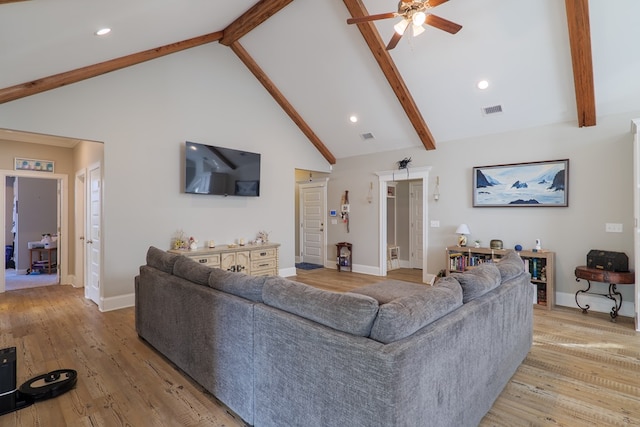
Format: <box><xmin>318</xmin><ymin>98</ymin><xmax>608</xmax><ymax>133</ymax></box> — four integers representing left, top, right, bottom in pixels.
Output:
<box><xmin>0</xmin><ymin>0</ymin><xmax>640</xmax><ymax>158</ymax></box>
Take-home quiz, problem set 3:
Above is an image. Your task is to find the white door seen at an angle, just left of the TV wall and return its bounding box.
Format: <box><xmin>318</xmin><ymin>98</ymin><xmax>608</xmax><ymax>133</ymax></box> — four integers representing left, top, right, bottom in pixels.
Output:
<box><xmin>85</xmin><ymin>165</ymin><xmax>102</xmax><ymax>307</ymax></box>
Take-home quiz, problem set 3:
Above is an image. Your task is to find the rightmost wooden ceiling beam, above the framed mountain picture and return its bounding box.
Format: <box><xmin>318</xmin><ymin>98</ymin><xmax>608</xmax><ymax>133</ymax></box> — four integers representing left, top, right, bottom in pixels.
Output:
<box><xmin>565</xmin><ymin>0</ymin><xmax>596</xmax><ymax>127</ymax></box>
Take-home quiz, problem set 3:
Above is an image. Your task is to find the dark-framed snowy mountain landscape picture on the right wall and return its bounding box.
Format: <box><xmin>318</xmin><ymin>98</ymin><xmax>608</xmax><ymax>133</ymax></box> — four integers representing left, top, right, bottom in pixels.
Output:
<box><xmin>473</xmin><ymin>159</ymin><xmax>569</xmax><ymax>207</ymax></box>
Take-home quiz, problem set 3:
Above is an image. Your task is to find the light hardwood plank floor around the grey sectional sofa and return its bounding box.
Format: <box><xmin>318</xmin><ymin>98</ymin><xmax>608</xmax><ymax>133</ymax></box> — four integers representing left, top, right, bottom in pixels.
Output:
<box><xmin>0</xmin><ymin>269</ymin><xmax>640</xmax><ymax>427</ymax></box>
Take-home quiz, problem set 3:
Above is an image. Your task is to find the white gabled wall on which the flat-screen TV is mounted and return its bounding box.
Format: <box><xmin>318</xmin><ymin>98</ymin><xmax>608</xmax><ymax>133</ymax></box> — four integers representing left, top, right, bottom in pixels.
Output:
<box><xmin>0</xmin><ymin>44</ymin><xmax>329</xmax><ymax>305</ymax></box>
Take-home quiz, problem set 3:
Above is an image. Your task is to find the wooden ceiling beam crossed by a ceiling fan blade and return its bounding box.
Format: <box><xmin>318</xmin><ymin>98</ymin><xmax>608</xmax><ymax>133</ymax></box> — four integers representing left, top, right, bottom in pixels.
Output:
<box><xmin>344</xmin><ymin>0</ymin><xmax>436</xmax><ymax>150</ymax></box>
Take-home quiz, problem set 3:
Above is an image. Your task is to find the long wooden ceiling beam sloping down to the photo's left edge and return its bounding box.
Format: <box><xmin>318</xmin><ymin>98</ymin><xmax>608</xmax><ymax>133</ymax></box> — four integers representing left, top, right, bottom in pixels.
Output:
<box><xmin>0</xmin><ymin>31</ymin><xmax>223</xmax><ymax>104</ymax></box>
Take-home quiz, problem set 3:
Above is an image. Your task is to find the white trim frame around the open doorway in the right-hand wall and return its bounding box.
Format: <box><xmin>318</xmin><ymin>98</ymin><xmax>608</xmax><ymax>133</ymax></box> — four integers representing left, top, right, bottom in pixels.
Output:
<box><xmin>376</xmin><ymin>166</ymin><xmax>433</xmax><ymax>283</ymax></box>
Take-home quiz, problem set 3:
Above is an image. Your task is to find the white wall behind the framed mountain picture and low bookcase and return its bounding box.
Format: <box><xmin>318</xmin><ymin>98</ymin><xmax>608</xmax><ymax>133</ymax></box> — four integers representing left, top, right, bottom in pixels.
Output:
<box><xmin>327</xmin><ymin>112</ymin><xmax>638</xmax><ymax>313</ymax></box>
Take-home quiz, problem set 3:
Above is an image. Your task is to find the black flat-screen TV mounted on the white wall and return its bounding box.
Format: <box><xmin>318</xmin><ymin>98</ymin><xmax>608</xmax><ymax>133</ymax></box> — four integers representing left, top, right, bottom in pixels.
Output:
<box><xmin>185</xmin><ymin>141</ymin><xmax>260</xmax><ymax>197</ymax></box>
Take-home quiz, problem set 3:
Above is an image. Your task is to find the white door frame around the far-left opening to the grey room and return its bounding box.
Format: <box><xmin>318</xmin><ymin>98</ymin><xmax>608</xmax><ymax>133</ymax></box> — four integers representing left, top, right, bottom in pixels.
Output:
<box><xmin>0</xmin><ymin>169</ymin><xmax>70</xmax><ymax>294</ymax></box>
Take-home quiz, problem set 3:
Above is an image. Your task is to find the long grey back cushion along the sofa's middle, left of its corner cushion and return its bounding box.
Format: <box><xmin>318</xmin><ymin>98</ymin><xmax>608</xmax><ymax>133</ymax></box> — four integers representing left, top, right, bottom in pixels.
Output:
<box><xmin>262</xmin><ymin>277</ymin><xmax>378</xmax><ymax>337</ymax></box>
